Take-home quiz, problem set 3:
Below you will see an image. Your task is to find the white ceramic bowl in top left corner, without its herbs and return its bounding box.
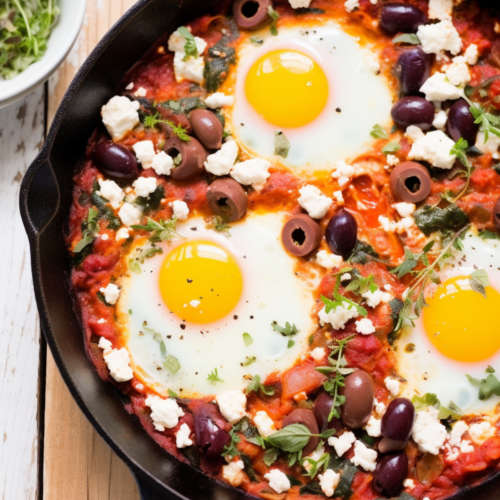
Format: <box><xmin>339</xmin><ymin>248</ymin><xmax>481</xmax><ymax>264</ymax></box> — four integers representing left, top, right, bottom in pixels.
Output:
<box><xmin>0</xmin><ymin>0</ymin><xmax>87</xmax><ymax>108</ymax></box>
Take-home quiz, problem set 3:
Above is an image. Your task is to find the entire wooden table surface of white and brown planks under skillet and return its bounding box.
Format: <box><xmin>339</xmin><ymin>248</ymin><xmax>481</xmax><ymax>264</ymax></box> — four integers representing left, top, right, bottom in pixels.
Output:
<box><xmin>0</xmin><ymin>0</ymin><xmax>139</xmax><ymax>500</ymax></box>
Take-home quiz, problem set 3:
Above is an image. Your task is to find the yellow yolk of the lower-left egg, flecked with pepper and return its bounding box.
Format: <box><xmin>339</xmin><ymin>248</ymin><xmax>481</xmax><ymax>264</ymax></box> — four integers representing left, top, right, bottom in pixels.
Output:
<box><xmin>160</xmin><ymin>241</ymin><xmax>243</xmax><ymax>323</ymax></box>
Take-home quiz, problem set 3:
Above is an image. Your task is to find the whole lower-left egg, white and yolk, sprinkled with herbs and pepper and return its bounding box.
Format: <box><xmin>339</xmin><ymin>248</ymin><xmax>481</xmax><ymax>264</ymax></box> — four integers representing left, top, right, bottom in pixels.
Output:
<box><xmin>118</xmin><ymin>213</ymin><xmax>319</xmax><ymax>397</ymax></box>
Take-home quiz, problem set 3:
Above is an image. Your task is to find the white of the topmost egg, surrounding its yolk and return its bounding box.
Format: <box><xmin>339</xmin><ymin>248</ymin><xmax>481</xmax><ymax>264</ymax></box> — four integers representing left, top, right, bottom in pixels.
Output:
<box><xmin>229</xmin><ymin>23</ymin><xmax>393</xmax><ymax>171</ymax></box>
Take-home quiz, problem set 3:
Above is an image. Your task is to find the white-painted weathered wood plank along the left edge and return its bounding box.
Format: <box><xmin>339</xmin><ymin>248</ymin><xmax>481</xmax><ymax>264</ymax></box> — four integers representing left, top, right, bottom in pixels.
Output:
<box><xmin>0</xmin><ymin>86</ymin><xmax>45</xmax><ymax>500</ymax></box>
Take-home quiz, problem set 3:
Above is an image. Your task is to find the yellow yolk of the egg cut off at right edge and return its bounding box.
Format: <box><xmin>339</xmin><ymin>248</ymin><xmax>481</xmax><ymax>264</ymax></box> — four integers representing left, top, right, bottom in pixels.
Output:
<box><xmin>423</xmin><ymin>276</ymin><xmax>500</xmax><ymax>362</ymax></box>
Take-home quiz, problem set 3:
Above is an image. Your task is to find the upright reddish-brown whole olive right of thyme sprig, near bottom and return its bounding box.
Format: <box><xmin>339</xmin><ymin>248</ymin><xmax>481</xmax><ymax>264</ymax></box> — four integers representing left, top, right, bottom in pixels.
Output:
<box><xmin>342</xmin><ymin>369</ymin><xmax>375</xmax><ymax>429</ymax></box>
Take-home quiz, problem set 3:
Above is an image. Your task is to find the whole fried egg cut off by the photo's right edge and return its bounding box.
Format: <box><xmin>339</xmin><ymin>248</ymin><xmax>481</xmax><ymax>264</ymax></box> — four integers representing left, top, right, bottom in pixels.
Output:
<box><xmin>397</xmin><ymin>230</ymin><xmax>500</xmax><ymax>414</ymax></box>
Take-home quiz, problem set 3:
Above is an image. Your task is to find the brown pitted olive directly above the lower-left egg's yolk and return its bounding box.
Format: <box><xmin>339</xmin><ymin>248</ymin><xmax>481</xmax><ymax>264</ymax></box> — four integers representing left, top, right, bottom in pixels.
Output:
<box><xmin>207</xmin><ymin>178</ymin><xmax>248</xmax><ymax>222</ymax></box>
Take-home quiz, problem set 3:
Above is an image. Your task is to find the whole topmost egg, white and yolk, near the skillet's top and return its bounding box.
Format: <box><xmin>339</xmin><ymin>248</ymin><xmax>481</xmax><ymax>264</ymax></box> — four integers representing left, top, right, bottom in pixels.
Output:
<box><xmin>228</xmin><ymin>23</ymin><xmax>393</xmax><ymax>171</ymax></box>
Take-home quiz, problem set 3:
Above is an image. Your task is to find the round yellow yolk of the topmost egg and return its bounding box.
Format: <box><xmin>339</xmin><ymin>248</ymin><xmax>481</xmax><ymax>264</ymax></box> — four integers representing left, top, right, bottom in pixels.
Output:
<box><xmin>245</xmin><ymin>50</ymin><xmax>328</xmax><ymax>128</ymax></box>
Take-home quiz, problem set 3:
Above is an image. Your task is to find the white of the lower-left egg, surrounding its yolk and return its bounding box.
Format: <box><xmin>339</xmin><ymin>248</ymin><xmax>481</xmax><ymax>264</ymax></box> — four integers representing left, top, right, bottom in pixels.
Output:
<box><xmin>118</xmin><ymin>213</ymin><xmax>318</xmax><ymax>397</ymax></box>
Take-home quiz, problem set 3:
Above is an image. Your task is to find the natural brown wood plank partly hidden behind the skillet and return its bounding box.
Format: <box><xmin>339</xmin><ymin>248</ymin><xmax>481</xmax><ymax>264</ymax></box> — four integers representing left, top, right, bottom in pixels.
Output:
<box><xmin>43</xmin><ymin>0</ymin><xmax>139</xmax><ymax>500</ymax></box>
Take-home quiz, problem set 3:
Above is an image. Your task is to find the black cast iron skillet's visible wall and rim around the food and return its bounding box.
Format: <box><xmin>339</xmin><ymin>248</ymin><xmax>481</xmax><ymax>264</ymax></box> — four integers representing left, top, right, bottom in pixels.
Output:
<box><xmin>20</xmin><ymin>0</ymin><xmax>500</xmax><ymax>500</ymax></box>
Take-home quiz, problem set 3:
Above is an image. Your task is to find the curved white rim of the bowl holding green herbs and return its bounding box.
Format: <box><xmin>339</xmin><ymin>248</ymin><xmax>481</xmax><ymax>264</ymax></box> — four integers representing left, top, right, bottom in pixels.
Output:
<box><xmin>0</xmin><ymin>0</ymin><xmax>87</xmax><ymax>108</ymax></box>
